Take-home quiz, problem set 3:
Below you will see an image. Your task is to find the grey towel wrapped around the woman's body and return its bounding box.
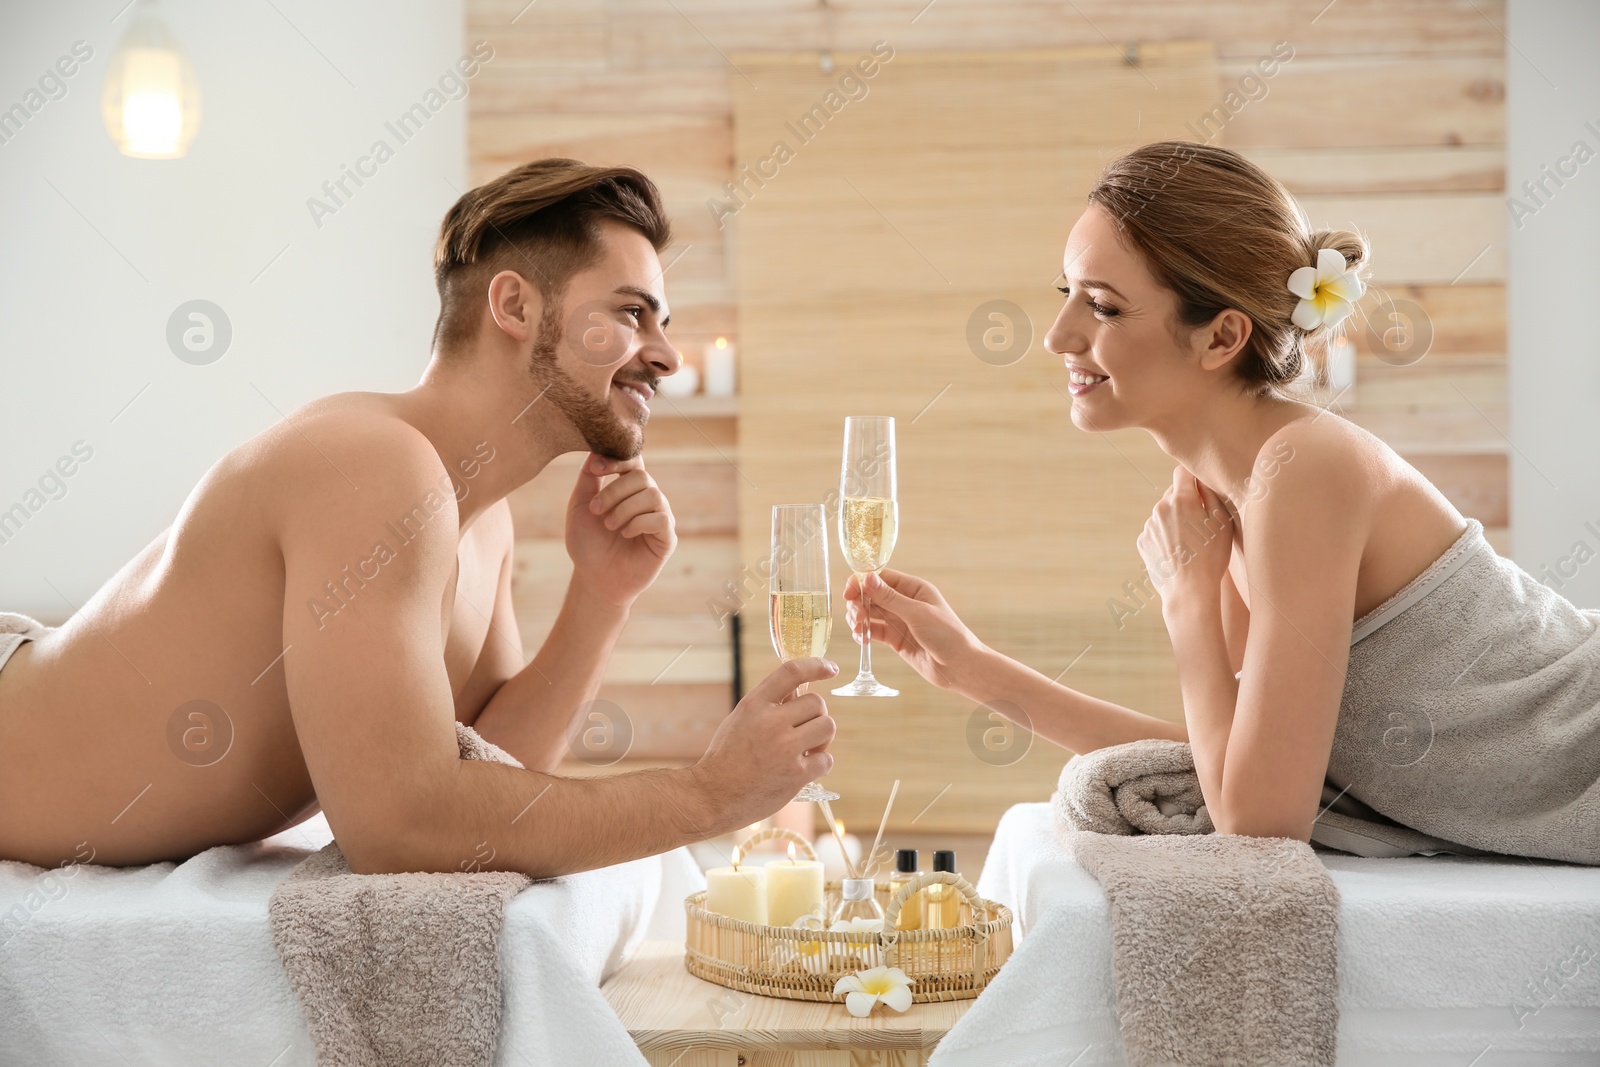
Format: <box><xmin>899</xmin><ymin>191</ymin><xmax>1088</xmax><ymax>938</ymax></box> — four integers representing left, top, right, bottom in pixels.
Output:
<box><xmin>1328</xmin><ymin>518</ymin><xmax>1600</xmax><ymax>864</ymax></box>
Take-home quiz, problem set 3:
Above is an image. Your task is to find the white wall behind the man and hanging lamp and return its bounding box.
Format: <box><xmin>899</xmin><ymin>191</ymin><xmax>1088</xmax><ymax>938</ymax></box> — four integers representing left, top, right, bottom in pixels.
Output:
<box><xmin>0</xmin><ymin>0</ymin><xmax>470</xmax><ymax>619</ymax></box>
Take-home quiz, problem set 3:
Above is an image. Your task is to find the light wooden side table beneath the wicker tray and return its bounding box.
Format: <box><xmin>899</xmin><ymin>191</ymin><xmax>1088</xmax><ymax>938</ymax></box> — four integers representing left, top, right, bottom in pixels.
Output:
<box><xmin>600</xmin><ymin>941</ymin><xmax>973</xmax><ymax>1067</ymax></box>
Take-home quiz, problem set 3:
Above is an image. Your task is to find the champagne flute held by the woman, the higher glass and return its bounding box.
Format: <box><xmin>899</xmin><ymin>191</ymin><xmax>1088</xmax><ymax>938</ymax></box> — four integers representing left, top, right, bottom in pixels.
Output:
<box><xmin>834</xmin><ymin>414</ymin><xmax>899</xmax><ymax>696</ymax></box>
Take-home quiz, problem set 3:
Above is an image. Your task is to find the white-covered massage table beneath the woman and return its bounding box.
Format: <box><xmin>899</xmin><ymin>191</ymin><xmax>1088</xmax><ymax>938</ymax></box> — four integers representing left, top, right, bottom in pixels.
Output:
<box><xmin>931</xmin><ymin>803</ymin><xmax>1600</xmax><ymax>1067</ymax></box>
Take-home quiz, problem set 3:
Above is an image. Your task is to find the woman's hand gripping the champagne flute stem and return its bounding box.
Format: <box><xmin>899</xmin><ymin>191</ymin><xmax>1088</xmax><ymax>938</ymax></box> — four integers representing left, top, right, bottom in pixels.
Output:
<box><xmin>845</xmin><ymin>568</ymin><xmax>987</xmax><ymax>691</ymax></box>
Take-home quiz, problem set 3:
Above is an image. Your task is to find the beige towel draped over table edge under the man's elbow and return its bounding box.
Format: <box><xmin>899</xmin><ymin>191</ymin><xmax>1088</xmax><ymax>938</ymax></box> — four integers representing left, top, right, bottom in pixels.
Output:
<box><xmin>269</xmin><ymin>723</ymin><xmax>531</xmax><ymax>1067</ymax></box>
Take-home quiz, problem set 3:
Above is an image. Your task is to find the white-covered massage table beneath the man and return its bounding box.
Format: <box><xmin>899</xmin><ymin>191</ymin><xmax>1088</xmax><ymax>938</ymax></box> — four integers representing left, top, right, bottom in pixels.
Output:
<box><xmin>0</xmin><ymin>816</ymin><xmax>706</xmax><ymax>1067</ymax></box>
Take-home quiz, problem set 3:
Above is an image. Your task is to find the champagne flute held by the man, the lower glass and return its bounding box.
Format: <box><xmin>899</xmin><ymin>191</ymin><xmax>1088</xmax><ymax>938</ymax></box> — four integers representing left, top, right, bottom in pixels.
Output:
<box><xmin>768</xmin><ymin>504</ymin><xmax>838</xmax><ymax>800</ymax></box>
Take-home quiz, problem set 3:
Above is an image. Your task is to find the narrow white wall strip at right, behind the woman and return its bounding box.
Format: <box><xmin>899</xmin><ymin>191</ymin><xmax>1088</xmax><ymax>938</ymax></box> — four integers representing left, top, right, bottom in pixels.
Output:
<box><xmin>1506</xmin><ymin>0</ymin><xmax>1600</xmax><ymax>608</ymax></box>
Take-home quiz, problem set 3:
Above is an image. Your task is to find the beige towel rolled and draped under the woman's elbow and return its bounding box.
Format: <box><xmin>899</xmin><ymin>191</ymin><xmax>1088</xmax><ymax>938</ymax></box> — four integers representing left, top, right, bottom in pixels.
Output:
<box><xmin>1051</xmin><ymin>741</ymin><xmax>1339</xmax><ymax>1067</ymax></box>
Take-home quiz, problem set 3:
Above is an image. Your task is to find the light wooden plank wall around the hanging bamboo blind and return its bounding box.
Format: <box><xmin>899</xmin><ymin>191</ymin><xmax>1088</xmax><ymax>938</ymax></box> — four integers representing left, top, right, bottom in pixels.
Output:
<box><xmin>467</xmin><ymin>0</ymin><xmax>1509</xmax><ymax>830</ymax></box>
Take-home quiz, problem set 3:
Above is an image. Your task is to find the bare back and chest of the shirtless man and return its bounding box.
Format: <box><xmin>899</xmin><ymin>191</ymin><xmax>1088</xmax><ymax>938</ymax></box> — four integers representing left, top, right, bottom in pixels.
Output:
<box><xmin>0</xmin><ymin>394</ymin><xmax>505</xmax><ymax>865</ymax></box>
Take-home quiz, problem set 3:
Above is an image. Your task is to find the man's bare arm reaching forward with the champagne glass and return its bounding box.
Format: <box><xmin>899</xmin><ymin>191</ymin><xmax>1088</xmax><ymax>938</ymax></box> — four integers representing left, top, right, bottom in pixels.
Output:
<box><xmin>278</xmin><ymin>427</ymin><xmax>837</xmax><ymax>877</ymax></box>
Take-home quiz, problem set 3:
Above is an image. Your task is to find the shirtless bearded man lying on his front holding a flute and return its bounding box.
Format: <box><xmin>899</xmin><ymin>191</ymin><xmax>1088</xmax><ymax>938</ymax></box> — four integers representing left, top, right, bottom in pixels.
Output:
<box><xmin>0</xmin><ymin>160</ymin><xmax>838</xmax><ymax>877</ymax></box>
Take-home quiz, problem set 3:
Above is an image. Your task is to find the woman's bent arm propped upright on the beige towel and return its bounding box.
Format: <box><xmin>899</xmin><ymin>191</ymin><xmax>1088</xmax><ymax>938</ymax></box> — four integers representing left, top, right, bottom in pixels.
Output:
<box><xmin>1147</xmin><ymin>424</ymin><xmax>1370</xmax><ymax>840</ymax></box>
